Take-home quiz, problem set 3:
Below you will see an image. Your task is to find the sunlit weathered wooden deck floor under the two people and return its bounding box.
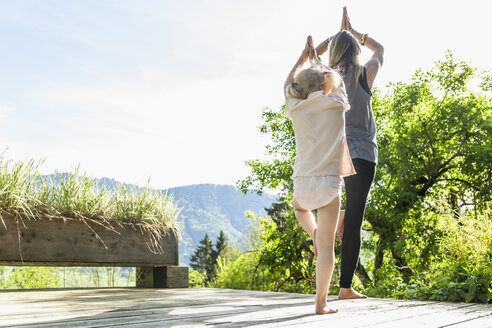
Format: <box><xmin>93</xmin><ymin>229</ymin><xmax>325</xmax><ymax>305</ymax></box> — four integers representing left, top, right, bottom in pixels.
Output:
<box><xmin>0</xmin><ymin>288</ymin><xmax>492</xmax><ymax>328</ymax></box>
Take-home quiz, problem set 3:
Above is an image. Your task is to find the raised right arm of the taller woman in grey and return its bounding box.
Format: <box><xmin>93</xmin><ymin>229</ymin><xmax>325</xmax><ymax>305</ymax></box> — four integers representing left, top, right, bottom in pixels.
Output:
<box><xmin>342</xmin><ymin>7</ymin><xmax>384</xmax><ymax>89</ymax></box>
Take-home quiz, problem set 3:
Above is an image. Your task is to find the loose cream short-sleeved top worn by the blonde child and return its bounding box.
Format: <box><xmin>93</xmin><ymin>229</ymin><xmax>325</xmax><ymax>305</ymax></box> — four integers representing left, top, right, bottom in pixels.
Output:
<box><xmin>285</xmin><ymin>90</ymin><xmax>355</xmax><ymax>178</ymax></box>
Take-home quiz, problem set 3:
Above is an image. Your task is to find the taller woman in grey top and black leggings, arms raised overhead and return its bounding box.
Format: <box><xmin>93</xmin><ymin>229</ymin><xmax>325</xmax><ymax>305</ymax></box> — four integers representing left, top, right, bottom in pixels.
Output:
<box><xmin>316</xmin><ymin>7</ymin><xmax>384</xmax><ymax>299</ymax></box>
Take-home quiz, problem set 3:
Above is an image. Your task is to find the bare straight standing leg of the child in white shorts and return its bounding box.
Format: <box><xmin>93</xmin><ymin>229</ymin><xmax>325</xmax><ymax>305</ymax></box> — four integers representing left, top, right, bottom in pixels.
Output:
<box><xmin>315</xmin><ymin>195</ymin><xmax>340</xmax><ymax>314</ymax></box>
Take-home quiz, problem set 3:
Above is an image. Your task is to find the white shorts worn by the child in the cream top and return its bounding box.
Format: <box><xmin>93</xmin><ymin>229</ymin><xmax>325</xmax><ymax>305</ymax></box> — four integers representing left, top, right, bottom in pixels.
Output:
<box><xmin>294</xmin><ymin>175</ymin><xmax>342</xmax><ymax>211</ymax></box>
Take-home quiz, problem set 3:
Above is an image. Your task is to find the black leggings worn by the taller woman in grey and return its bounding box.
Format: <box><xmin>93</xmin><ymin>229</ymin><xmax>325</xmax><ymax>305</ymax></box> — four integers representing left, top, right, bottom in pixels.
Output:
<box><xmin>340</xmin><ymin>158</ymin><xmax>376</xmax><ymax>288</ymax></box>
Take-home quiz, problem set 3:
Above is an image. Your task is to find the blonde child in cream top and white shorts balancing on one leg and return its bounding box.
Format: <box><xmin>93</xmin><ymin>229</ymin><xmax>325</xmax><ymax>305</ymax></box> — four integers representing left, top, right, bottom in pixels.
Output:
<box><xmin>284</xmin><ymin>36</ymin><xmax>355</xmax><ymax>314</ymax></box>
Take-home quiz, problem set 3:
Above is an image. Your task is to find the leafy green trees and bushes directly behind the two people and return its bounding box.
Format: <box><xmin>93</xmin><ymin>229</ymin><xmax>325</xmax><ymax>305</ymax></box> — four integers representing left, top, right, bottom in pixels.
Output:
<box><xmin>238</xmin><ymin>53</ymin><xmax>492</xmax><ymax>302</ymax></box>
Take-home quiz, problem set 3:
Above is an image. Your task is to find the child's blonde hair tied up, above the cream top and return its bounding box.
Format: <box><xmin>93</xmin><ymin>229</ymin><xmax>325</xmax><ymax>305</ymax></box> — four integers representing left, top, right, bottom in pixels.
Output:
<box><xmin>285</xmin><ymin>67</ymin><xmax>341</xmax><ymax>99</ymax></box>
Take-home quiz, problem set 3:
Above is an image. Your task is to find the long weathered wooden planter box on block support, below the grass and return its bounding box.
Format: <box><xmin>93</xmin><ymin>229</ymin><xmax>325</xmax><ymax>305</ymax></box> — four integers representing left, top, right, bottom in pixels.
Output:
<box><xmin>0</xmin><ymin>212</ymin><xmax>188</xmax><ymax>287</ymax></box>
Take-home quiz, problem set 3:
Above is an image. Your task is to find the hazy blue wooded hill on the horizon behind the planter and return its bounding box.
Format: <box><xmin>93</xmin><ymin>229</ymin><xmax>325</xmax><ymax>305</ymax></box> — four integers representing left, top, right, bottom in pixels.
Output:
<box><xmin>44</xmin><ymin>175</ymin><xmax>277</xmax><ymax>265</ymax></box>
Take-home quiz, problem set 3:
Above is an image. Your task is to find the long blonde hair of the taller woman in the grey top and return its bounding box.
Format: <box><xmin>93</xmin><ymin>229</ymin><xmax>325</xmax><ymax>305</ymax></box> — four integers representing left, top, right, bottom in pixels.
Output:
<box><xmin>328</xmin><ymin>30</ymin><xmax>364</xmax><ymax>86</ymax></box>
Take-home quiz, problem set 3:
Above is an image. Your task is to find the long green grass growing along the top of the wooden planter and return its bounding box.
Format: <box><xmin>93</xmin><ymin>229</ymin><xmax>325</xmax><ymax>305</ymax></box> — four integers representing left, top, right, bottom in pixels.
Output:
<box><xmin>0</xmin><ymin>156</ymin><xmax>179</xmax><ymax>229</ymax></box>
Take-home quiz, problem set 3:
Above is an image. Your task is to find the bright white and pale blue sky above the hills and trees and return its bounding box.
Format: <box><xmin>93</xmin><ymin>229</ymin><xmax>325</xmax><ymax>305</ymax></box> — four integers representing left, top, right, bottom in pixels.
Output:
<box><xmin>0</xmin><ymin>0</ymin><xmax>492</xmax><ymax>188</ymax></box>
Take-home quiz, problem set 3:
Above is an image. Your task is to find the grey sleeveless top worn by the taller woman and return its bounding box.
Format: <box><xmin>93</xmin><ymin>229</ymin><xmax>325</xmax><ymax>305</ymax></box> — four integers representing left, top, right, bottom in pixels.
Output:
<box><xmin>343</xmin><ymin>68</ymin><xmax>378</xmax><ymax>163</ymax></box>
